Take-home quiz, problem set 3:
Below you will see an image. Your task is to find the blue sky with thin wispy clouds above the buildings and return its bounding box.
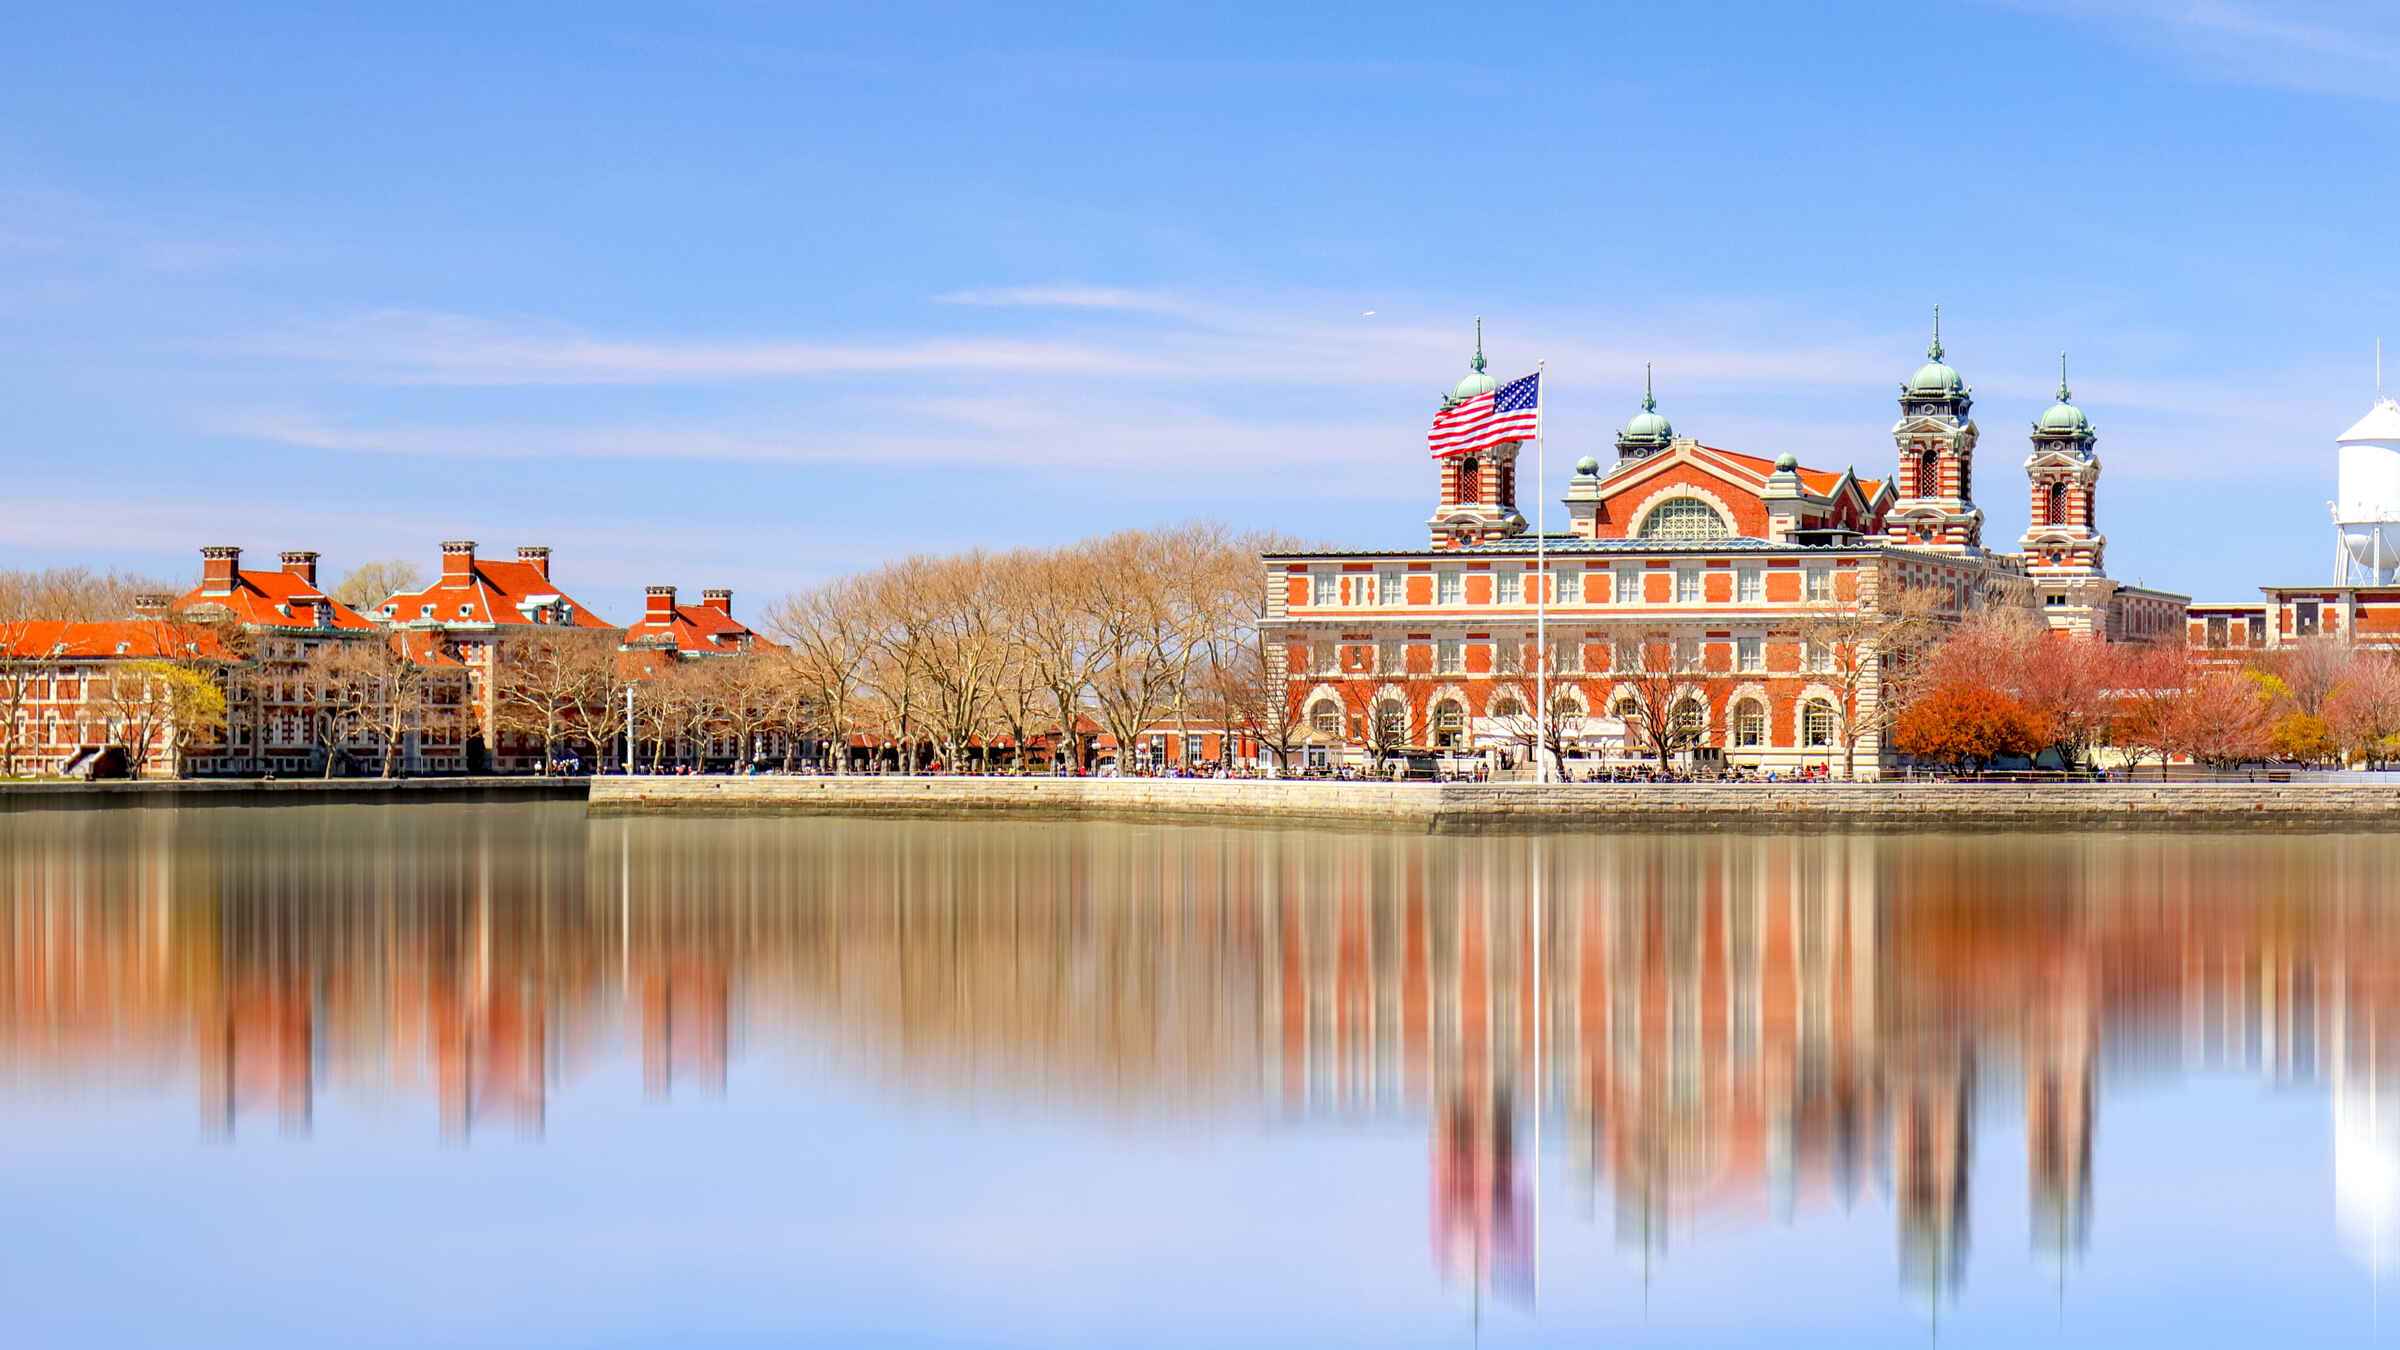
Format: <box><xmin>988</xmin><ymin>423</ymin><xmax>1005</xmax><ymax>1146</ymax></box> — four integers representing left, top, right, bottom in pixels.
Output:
<box><xmin>0</xmin><ymin>0</ymin><xmax>2400</xmax><ymax>617</ymax></box>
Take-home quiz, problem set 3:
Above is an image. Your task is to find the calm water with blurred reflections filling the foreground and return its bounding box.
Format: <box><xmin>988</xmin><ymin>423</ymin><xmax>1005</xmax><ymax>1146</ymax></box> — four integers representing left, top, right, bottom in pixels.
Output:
<box><xmin>0</xmin><ymin>807</ymin><xmax>2400</xmax><ymax>1348</ymax></box>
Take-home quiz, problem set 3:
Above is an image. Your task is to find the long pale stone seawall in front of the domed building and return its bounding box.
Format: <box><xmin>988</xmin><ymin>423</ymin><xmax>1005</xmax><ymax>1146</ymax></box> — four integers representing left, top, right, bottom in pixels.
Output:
<box><xmin>590</xmin><ymin>778</ymin><xmax>2400</xmax><ymax>831</ymax></box>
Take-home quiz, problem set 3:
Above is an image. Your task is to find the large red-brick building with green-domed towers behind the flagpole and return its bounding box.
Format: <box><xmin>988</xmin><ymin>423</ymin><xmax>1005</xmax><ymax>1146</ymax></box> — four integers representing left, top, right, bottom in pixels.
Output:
<box><xmin>1265</xmin><ymin>329</ymin><xmax>2189</xmax><ymax>778</ymax></box>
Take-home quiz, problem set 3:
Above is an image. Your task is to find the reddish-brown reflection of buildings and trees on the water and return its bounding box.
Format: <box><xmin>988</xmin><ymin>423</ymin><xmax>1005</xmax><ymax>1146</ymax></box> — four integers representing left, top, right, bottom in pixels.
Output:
<box><xmin>0</xmin><ymin>807</ymin><xmax>2400</xmax><ymax>1300</ymax></box>
